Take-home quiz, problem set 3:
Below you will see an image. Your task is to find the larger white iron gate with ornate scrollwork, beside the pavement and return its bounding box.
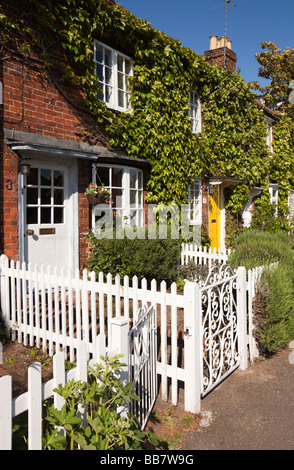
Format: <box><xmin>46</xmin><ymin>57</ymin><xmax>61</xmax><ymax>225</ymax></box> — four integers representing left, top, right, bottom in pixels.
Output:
<box><xmin>201</xmin><ymin>265</ymin><xmax>240</xmax><ymax>396</ymax></box>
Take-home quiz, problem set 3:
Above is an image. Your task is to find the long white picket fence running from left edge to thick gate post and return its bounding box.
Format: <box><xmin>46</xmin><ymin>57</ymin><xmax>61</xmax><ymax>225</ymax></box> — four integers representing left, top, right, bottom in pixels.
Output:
<box><xmin>0</xmin><ymin>255</ymin><xmax>191</xmax><ymax>412</ymax></box>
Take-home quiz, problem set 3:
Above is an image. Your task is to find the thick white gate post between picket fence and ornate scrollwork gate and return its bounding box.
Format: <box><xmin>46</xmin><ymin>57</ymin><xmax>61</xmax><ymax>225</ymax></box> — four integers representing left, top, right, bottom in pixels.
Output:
<box><xmin>184</xmin><ymin>282</ymin><xmax>203</xmax><ymax>414</ymax></box>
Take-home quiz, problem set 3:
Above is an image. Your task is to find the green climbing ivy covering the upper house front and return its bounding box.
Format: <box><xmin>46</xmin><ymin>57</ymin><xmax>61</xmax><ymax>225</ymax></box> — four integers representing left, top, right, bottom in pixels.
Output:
<box><xmin>0</xmin><ymin>0</ymin><xmax>293</xmax><ymax>216</ymax></box>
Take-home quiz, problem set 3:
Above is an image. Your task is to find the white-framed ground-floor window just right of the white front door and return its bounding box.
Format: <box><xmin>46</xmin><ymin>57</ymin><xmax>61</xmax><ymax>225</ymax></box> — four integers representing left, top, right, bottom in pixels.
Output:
<box><xmin>92</xmin><ymin>163</ymin><xmax>144</xmax><ymax>227</ymax></box>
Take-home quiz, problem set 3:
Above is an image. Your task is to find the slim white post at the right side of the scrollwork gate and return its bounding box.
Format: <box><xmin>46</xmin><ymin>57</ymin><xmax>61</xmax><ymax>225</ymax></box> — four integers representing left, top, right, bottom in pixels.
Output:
<box><xmin>237</xmin><ymin>267</ymin><xmax>248</xmax><ymax>370</ymax></box>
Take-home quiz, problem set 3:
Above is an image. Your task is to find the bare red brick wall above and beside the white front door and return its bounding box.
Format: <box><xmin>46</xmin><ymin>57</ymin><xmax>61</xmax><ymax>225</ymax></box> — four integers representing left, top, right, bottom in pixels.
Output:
<box><xmin>0</xmin><ymin>60</ymin><xmax>107</xmax><ymax>266</ymax></box>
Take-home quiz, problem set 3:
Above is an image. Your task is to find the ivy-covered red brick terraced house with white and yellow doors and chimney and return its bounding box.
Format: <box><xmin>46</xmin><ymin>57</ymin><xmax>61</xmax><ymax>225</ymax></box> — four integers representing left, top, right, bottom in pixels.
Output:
<box><xmin>0</xmin><ymin>0</ymin><xmax>290</xmax><ymax>268</ymax></box>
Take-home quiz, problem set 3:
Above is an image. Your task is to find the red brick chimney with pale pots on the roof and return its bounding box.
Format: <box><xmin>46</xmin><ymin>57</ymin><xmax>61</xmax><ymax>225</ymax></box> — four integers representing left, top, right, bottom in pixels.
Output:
<box><xmin>204</xmin><ymin>34</ymin><xmax>237</xmax><ymax>73</ymax></box>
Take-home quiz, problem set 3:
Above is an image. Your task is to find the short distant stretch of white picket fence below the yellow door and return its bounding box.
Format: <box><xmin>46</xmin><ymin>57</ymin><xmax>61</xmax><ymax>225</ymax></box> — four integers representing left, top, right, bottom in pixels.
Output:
<box><xmin>181</xmin><ymin>243</ymin><xmax>231</xmax><ymax>269</ymax></box>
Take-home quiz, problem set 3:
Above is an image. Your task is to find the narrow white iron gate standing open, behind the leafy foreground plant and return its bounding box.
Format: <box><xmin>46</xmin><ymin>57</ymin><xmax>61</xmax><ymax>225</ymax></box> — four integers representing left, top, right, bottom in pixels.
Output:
<box><xmin>129</xmin><ymin>306</ymin><xmax>157</xmax><ymax>429</ymax></box>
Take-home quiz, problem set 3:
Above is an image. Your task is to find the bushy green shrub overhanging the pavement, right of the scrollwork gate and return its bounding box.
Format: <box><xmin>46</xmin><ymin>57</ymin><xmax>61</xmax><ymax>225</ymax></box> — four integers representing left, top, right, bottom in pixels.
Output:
<box><xmin>229</xmin><ymin>230</ymin><xmax>294</xmax><ymax>353</ymax></box>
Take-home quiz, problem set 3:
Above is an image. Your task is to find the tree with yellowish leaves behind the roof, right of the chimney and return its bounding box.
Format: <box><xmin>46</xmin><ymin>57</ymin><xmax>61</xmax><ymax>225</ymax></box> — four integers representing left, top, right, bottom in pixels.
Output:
<box><xmin>252</xmin><ymin>41</ymin><xmax>294</xmax><ymax>119</ymax></box>
